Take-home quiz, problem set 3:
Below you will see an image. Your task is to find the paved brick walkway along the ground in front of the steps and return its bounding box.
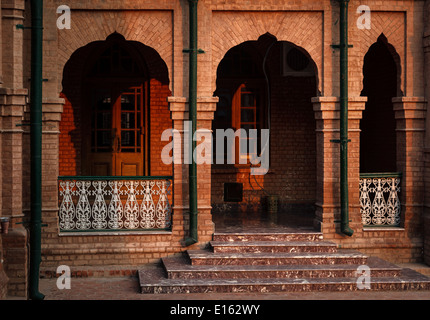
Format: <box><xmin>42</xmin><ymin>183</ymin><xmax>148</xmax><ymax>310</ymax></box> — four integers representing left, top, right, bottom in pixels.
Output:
<box><xmin>4</xmin><ymin>276</ymin><xmax>424</xmax><ymax>300</ymax></box>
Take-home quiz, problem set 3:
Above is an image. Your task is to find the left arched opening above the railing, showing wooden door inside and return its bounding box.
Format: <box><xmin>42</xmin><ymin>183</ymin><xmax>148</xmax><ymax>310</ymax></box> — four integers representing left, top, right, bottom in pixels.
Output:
<box><xmin>59</xmin><ymin>33</ymin><xmax>172</xmax><ymax>176</ymax></box>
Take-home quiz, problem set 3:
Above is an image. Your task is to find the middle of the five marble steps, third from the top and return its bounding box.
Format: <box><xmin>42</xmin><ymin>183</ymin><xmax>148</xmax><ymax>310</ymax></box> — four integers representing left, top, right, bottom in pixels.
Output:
<box><xmin>187</xmin><ymin>250</ymin><xmax>367</xmax><ymax>265</ymax></box>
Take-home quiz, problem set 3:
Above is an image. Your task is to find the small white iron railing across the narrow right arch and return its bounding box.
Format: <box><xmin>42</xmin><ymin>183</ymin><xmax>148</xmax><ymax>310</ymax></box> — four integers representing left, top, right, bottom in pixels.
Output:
<box><xmin>360</xmin><ymin>173</ymin><xmax>401</xmax><ymax>227</ymax></box>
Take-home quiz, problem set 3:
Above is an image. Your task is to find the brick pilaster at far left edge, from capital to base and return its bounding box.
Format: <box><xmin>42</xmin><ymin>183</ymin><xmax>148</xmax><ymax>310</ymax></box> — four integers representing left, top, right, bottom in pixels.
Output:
<box><xmin>0</xmin><ymin>88</ymin><xmax>27</xmax><ymax>297</ymax></box>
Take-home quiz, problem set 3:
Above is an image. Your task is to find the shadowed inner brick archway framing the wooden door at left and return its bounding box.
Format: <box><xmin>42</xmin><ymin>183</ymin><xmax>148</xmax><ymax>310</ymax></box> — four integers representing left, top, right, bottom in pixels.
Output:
<box><xmin>59</xmin><ymin>33</ymin><xmax>172</xmax><ymax>176</ymax></box>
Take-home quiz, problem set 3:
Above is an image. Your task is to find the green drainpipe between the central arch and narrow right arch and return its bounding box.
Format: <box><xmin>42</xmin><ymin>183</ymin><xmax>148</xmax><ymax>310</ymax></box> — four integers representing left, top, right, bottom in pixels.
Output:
<box><xmin>339</xmin><ymin>0</ymin><xmax>354</xmax><ymax>236</ymax></box>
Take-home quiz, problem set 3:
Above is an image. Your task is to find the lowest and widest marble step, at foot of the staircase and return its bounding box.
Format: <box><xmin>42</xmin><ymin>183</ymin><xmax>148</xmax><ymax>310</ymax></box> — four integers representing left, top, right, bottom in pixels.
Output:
<box><xmin>138</xmin><ymin>268</ymin><xmax>430</xmax><ymax>294</ymax></box>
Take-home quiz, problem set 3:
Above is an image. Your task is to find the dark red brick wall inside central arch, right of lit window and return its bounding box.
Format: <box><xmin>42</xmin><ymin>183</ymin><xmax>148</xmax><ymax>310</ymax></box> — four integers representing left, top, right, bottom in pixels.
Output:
<box><xmin>267</xmin><ymin>78</ymin><xmax>316</xmax><ymax>203</ymax></box>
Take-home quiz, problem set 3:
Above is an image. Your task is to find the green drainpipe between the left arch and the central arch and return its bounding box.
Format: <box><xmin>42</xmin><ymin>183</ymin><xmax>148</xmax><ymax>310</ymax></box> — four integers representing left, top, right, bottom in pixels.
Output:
<box><xmin>184</xmin><ymin>0</ymin><xmax>198</xmax><ymax>246</ymax></box>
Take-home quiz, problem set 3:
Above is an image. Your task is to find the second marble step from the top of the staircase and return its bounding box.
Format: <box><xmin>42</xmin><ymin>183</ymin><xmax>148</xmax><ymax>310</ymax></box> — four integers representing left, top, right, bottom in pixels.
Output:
<box><xmin>210</xmin><ymin>241</ymin><xmax>337</xmax><ymax>253</ymax></box>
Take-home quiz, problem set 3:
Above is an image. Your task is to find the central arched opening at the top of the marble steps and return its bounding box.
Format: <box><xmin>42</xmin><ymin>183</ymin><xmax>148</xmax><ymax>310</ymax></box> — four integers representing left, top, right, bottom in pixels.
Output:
<box><xmin>212</xmin><ymin>34</ymin><xmax>317</xmax><ymax>230</ymax></box>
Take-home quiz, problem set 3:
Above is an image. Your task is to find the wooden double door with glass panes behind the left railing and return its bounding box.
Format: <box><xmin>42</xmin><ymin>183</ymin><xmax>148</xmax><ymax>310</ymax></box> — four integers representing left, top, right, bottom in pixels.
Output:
<box><xmin>88</xmin><ymin>84</ymin><xmax>147</xmax><ymax>176</ymax></box>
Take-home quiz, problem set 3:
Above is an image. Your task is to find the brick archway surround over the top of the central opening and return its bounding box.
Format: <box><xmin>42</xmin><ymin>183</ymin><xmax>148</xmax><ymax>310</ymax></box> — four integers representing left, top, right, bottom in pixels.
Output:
<box><xmin>211</xmin><ymin>12</ymin><xmax>323</xmax><ymax>96</ymax></box>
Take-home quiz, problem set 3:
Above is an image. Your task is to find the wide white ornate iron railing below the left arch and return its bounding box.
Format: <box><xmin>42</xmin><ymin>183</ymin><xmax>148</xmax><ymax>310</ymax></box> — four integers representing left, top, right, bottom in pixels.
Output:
<box><xmin>58</xmin><ymin>176</ymin><xmax>172</xmax><ymax>232</ymax></box>
